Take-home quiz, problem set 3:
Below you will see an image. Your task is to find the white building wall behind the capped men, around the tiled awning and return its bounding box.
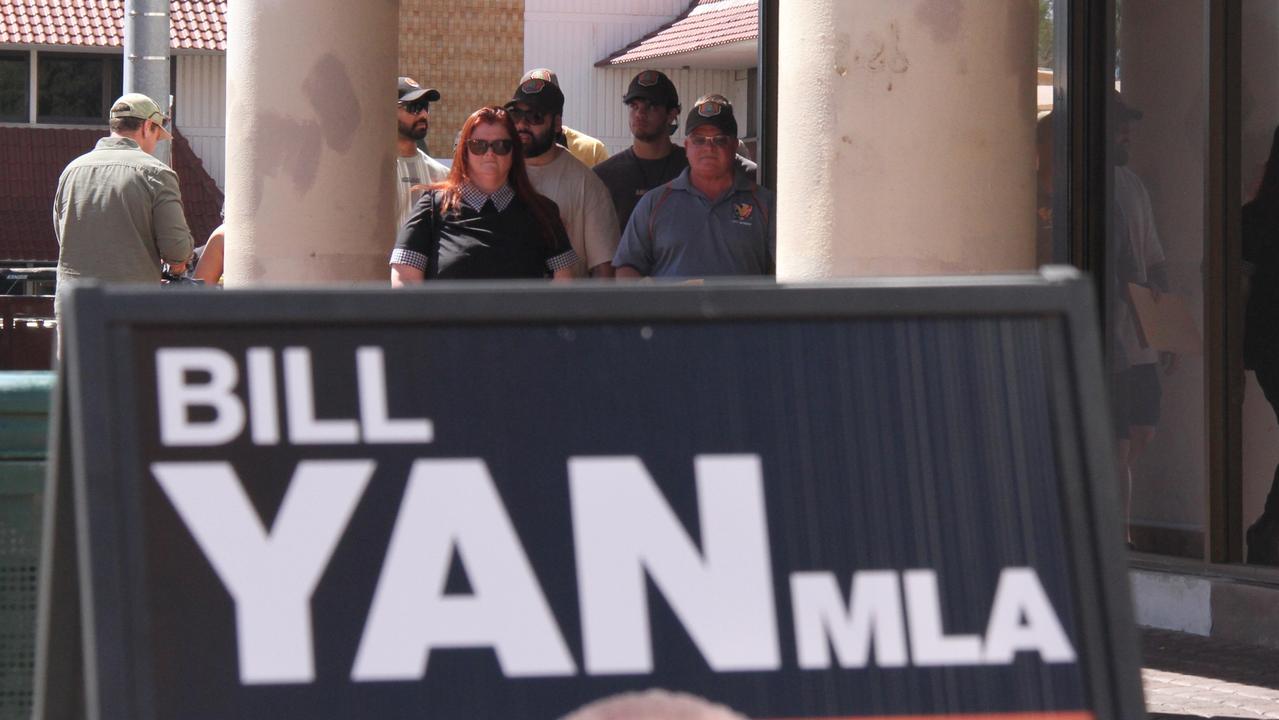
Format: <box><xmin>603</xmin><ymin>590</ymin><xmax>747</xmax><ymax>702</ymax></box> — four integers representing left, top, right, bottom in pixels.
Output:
<box><xmin>521</xmin><ymin>0</ymin><xmax>747</xmax><ymax>152</ymax></box>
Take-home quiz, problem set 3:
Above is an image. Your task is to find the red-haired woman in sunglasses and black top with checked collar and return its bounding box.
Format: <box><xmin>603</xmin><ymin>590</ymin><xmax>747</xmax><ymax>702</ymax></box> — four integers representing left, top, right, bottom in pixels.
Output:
<box><xmin>390</xmin><ymin>107</ymin><xmax>577</xmax><ymax>288</ymax></box>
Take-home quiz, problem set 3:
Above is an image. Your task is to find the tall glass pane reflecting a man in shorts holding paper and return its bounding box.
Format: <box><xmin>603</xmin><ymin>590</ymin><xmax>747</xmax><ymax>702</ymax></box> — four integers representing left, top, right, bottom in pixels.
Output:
<box><xmin>1105</xmin><ymin>0</ymin><xmax>1207</xmax><ymax>558</ymax></box>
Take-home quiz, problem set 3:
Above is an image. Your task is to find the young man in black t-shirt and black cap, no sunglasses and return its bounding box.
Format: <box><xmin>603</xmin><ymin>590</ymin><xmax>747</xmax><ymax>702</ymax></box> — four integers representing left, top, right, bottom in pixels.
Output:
<box><xmin>595</xmin><ymin>70</ymin><xmax>688</xmax><ymax>228</ymax></box>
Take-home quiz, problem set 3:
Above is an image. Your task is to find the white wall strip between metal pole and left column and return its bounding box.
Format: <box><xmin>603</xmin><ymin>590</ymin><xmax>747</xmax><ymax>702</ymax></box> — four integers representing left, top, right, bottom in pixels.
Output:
<box><xmin>173</xmin><ymin>52</ymin><xmax>226</xmax><ymax>192</ymax></box>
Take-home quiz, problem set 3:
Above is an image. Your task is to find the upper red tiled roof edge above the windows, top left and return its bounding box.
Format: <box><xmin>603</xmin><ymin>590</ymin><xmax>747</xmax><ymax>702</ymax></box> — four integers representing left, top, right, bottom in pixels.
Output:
<box><xmin>0</xmin><ymin>0</ymin><xmax>226</xmax><ymax>50</ymax></box>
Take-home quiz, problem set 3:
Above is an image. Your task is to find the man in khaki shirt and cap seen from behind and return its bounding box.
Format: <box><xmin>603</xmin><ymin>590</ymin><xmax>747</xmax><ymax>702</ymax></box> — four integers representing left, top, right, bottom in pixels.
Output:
<box><xmin>54</xmin><ymin>93</ymin><xmax>193</xmax><ymax>317</ymax></box>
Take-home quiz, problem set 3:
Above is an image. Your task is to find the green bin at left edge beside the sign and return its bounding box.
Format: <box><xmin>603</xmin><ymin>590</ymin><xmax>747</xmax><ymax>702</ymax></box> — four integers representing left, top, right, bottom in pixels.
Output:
<box><xmin>0</xmin><ymin>372</ymin><xmax>54</xmax><ymax>720</ymax></box>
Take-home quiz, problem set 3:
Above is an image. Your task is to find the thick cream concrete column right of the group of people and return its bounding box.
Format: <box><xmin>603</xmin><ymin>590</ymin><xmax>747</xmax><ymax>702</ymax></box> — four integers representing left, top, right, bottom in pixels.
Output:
<box><xmin>778</xmin><ymin>0</ymin><xmax>1036</xmax><ymax>280</ymax></box>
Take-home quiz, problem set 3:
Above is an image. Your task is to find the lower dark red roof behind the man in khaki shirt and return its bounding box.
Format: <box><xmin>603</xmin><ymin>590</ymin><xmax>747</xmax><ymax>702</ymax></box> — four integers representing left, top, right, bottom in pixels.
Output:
<box><xmin>0</xmin><ymin>127</ymin><xmax>223</xmax><ymax>262</ymax></box>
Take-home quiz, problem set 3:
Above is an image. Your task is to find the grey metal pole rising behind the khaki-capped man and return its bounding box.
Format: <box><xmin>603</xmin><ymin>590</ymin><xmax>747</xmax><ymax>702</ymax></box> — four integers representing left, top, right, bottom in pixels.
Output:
<box><xmin>124</xmin><ymin>0</ymin><xmax>173</xmax><ymax>162</ymax></box>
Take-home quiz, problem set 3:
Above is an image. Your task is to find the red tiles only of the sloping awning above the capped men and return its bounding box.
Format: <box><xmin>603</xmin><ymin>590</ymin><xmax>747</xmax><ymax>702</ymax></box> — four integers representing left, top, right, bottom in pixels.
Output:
<box><xmin>596</xmin><ymin>0</ymin><xmax>760</xmax><ymax>67</ymax></box>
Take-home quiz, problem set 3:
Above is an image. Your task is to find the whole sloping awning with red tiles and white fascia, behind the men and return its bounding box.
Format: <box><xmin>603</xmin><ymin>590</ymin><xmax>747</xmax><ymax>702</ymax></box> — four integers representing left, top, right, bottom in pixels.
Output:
<box><xmin>595</xmin><ymin>0</ymin><xmax>760</xmax><ymax>69</ymax></box>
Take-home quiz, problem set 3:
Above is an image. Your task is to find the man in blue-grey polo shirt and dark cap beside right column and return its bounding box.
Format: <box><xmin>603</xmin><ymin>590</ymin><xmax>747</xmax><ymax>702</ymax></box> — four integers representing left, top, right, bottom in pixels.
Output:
<box><xmin>613</xmin><ymin>95</ymin><xmax>776</xmax><ymax>279</ymax></box>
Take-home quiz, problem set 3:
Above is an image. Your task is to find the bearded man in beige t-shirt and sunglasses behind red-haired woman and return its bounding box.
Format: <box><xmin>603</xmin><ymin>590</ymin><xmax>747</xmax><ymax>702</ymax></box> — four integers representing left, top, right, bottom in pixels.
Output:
<box><xmin>506</xmin><ymin>77</ymin><xmax>620</xmax><ymax>278</ymax></box>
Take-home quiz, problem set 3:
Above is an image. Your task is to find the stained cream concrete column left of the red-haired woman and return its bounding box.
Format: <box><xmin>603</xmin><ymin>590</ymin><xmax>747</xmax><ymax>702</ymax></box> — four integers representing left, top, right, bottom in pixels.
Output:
<box><xmin>225</xmin><ymin>0</ymin><xmax>399</xmax><ymax>286</ymax></box>
